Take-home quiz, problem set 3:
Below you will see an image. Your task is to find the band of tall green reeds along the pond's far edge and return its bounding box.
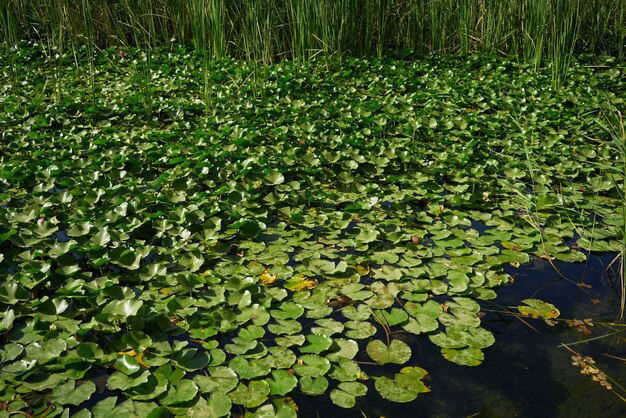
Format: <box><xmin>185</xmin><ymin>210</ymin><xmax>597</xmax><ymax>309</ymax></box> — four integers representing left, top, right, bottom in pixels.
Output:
<box><xmin>0</xmin><ymin>0</ymin><xmax>626</xmax><ymax>78</ymax></box>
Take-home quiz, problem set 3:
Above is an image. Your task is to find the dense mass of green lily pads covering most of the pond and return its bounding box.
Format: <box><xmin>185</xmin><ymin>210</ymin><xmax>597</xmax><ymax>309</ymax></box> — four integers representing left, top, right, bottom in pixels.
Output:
<box><xmin>0</xmin><ymin>44</ymin><xmax>625</xmax><ymax>417</ymax></box>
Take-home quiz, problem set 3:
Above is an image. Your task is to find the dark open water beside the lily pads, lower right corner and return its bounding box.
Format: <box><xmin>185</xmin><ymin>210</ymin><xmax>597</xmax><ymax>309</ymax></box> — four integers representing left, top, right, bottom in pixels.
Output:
<box><xmin>295</xmin><ymin>254</ymin><xmax>626</xmax><ymax>418</ymax></box>
